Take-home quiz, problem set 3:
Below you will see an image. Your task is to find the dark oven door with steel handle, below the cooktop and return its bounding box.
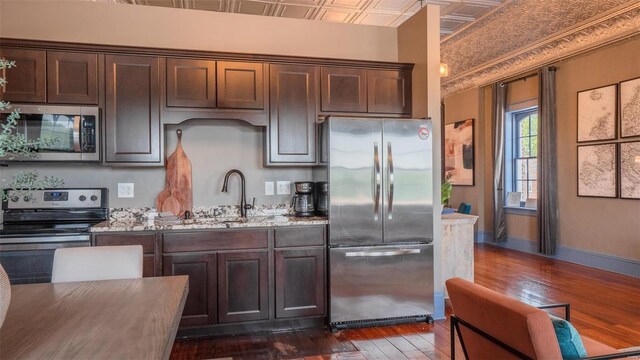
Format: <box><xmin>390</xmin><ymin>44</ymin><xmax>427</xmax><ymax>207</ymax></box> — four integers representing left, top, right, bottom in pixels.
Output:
<box><xmin>0</xmin><ymin>234</ymin><xmax>91</xmax><ymax>285</ymax></box>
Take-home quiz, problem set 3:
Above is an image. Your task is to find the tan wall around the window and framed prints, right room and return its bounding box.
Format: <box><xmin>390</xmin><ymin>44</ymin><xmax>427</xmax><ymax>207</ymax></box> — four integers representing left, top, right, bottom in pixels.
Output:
<box><xmin>445</xmin><ymin>36</ymin><xmax>640</xmax><ymax>259</ymax></box>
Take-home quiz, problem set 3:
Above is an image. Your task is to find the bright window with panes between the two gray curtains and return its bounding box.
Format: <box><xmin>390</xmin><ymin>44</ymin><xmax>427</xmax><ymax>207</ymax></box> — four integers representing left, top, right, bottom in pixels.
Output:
<box><xmin>505</xmin><ymin>108</ymin><xmax>538</xmax><ymax>207</ymax></box>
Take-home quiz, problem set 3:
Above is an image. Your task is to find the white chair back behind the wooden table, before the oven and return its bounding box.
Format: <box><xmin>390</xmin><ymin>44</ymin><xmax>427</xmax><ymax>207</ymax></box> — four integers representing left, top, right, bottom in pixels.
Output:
<box><xmin>51</xmin><ymin>245</ymin><xmax>142</xmax><ymax>283</ymax></box>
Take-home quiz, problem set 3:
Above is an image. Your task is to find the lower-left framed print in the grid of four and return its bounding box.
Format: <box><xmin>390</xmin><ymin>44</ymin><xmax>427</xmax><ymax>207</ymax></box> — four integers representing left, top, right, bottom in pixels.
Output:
<box><xmin>578</xmin><ymin>143</ymin><xmax>618</xmax><ymax>198</ymax></box>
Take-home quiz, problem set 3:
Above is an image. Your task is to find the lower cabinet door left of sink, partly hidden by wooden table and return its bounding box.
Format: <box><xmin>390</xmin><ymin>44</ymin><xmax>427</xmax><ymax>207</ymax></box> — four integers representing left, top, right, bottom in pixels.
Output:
<box><xmin>162</xmin><ymin>254</ymin><xmax>217</xmax><ymax>326</ymax></box>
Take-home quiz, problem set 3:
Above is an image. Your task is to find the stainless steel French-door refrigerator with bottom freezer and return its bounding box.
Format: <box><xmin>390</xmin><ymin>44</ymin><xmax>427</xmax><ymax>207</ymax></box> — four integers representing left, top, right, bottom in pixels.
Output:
<box><xmin>324</xmin><ymin>117</ymin><xmax>434</xmax><ymax>328</ymax></box>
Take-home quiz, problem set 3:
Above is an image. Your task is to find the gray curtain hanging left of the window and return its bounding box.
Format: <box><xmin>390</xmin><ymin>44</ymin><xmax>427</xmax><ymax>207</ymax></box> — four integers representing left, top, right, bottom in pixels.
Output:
<box><xmin>493</xmin><ymin>83</ymin><xmax>507</xmax><ymax>242</ymax></box>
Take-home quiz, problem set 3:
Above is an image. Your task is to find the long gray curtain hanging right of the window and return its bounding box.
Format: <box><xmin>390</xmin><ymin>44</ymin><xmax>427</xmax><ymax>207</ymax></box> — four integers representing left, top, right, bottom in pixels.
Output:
<box><xmin>538</xmin><ymin>67</ymin><xmax>558</xmax><ymax>255</ymax></box>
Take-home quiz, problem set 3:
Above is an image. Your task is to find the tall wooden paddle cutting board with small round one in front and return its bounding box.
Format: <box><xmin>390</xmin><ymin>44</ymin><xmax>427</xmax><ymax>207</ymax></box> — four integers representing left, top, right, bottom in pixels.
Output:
<box><xmin>156</xmin><ymin>129</ymin><xmax>193</xmax><ymax>217</ymax></box>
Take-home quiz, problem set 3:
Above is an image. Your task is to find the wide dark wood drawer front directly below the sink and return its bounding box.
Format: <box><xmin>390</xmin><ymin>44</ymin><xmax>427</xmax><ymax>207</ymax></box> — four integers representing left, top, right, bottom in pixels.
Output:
<box><xmin>162</xmin><ymin>230</ymin><xmax>269</xmax><ymax>253</ymax></box>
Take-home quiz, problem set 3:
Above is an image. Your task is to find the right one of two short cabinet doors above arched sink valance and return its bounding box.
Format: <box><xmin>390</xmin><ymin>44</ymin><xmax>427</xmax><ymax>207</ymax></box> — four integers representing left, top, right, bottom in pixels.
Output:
<box><xmin>217</xmin><ymin>61</ymin><xmax>264</xmax><ymax>109</ymax></box>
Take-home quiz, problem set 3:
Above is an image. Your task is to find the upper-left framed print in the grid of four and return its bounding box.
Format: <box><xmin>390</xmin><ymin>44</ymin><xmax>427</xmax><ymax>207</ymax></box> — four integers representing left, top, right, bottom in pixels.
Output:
<box><xmin>578</xmin><ymin>84</ymin><xmax>618</xmax><ymax>143</ymax></box>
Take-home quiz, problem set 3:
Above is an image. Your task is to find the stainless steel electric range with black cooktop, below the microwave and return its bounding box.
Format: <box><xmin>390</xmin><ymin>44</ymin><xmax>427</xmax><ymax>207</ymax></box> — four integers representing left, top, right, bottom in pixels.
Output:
<box><xmin>0</xmin><ymin>188</ymin><xmax>109</xmax><ymax>284</ymax></box>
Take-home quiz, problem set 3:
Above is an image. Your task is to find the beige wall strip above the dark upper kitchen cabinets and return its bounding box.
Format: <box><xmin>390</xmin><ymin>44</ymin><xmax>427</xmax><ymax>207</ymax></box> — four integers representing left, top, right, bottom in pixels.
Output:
<box><xmin>0</xmin><ymin>0</ymin><xmax>398</xmax><ymax>61</ymax></box>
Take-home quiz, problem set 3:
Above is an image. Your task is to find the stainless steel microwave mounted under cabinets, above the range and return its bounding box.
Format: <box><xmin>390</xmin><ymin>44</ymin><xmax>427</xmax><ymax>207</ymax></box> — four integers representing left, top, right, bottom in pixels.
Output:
<box><xmin>0</xmin><ymin>104</ymin><xmax>101</xmax><ymax>163</ymax></box>
